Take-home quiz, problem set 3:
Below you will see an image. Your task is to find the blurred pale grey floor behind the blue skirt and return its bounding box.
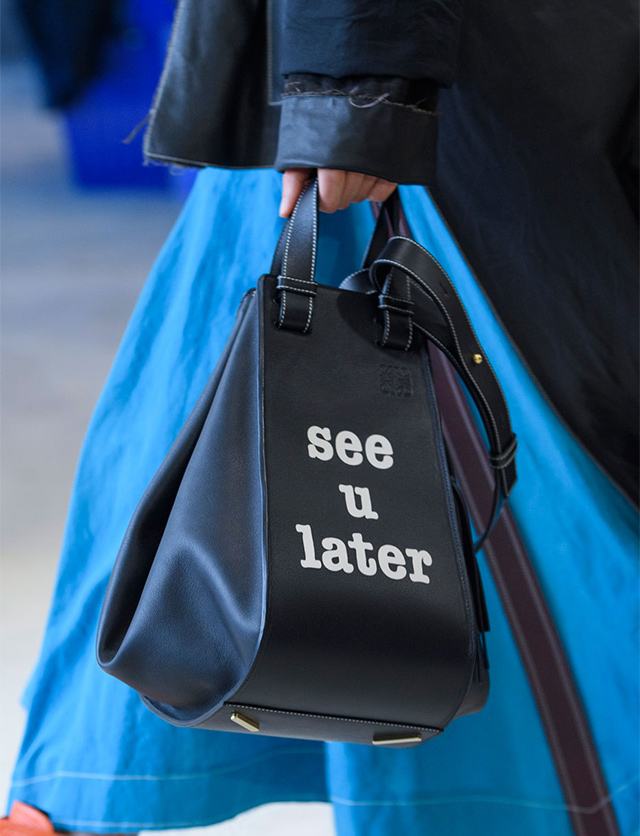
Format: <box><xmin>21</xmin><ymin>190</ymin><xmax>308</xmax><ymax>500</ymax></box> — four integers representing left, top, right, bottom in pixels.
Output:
<box><xmin>0</xmin><ymin>64</ymin><xmax>333</xmax><ymax>836</ymax></box>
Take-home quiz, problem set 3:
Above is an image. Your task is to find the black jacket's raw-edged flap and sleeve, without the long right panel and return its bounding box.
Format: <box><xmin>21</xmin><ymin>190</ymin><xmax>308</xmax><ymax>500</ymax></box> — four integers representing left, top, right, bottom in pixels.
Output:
<box><xmin>145</xmin><ymin>0</ymin><xmax>448</xmax><ymax>185</ymax></box>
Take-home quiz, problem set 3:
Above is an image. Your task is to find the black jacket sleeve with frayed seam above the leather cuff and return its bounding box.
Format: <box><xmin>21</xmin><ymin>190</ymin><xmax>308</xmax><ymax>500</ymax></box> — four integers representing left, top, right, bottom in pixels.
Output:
<box><xmin>274</xmin><ymin>0</ymin><xmax>461</xmax><ymax>185</ymax></box>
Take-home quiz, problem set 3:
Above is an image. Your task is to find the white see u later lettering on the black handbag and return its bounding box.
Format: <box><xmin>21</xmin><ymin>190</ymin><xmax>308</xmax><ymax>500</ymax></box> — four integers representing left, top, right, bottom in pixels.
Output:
<box><xmin>296</xmin><ymin>425</ymin><xmax>433</xmax><ymax>584</ymax></box>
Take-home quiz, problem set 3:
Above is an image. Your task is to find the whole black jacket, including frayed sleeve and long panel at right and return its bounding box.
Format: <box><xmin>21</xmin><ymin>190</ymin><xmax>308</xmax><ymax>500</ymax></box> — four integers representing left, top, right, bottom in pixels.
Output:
<box><xmin>145</xmin><ymin>0</ymin><xmax>638</xmax><ymax>500</ymax></box>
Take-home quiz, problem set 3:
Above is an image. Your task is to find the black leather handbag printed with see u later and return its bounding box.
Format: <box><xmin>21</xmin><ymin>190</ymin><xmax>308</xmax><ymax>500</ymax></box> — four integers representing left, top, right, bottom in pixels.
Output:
<box><xmin>97</xmin><ymin>179</ymin><xmax>516</xmax><ymax>747</ymax></box>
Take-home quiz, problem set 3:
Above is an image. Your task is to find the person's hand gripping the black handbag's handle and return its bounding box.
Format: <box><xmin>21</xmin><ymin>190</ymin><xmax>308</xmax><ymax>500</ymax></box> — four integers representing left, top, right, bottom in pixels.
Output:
<box><xmin>279</xmin><ymin>168</ymin><xmax>398</xmax><ymax>218</ymax></box>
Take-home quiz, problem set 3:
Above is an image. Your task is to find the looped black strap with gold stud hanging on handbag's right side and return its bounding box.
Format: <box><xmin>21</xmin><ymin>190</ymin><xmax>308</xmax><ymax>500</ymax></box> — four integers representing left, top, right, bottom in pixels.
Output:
<box><xmin>369</xmin><ymin>235</ymin><xmax>517</xmax><ymax>551</ymax></box>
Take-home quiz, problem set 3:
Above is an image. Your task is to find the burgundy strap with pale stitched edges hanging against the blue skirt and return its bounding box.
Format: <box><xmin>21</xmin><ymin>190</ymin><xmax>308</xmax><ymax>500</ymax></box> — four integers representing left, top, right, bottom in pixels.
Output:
<box><xmin>430</xmin><ymin>348</ymin><xmax>620</xmax><ymax>836</ymax></box>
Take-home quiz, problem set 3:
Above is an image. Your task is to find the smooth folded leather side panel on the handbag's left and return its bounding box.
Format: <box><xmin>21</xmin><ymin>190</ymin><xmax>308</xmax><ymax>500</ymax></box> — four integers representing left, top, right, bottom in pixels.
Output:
<box><xmin>97</xmin><ymin>294</ymin><xmax>265</xmax><ymax>725</ymax></box>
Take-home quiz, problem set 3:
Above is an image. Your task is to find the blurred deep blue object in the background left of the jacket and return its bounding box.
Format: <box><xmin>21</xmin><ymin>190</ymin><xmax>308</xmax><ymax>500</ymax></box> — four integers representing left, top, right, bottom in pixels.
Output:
<box><xmin>64</xmin><ymin>0</ymin><xmax>195</xmax><ymax>194</ymax></box>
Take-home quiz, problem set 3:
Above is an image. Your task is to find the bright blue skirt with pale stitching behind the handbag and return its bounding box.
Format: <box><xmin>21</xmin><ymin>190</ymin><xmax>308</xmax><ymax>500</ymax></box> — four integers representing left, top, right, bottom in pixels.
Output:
<box><xmin>10</xmin><ymin>169</ymin><xmax>638</xmax><ymax>836</ymax></box>
